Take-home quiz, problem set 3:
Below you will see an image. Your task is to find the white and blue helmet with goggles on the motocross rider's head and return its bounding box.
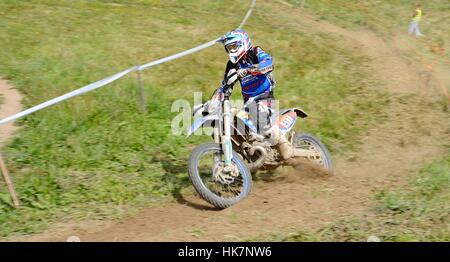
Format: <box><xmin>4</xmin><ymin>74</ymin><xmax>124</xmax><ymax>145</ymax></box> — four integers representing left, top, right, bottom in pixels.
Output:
<box><xmin>221</xmin><ymin>29</ymin><xmax>252</xmax><ymax>64</ymax></box>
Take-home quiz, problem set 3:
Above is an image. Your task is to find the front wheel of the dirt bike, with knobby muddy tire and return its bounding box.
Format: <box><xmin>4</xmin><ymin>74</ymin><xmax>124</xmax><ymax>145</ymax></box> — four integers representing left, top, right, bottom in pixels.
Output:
<box><xmin>188</xmin><ymin>143</ymin><xmax>252</xmax><ymax>209</ymax></box>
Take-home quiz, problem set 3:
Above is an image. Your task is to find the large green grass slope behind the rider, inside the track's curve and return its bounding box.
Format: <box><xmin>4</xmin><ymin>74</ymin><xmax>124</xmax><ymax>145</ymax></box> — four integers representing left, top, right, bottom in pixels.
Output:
<box><xmin>0</xmin><ymin>0</ymin><xmax>388</xmax><ymax>237</ymax></box>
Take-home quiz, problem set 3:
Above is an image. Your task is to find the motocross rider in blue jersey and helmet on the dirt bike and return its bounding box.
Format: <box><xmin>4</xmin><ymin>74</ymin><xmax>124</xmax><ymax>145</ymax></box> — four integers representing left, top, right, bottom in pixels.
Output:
<box><xmin>220</xmin><ymin>29</ymin><xmax>293</xmax><ymax>159</ymax></box>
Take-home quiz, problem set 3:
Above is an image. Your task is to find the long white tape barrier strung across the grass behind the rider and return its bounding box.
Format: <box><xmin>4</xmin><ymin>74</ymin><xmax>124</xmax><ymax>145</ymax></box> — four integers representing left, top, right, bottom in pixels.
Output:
<box><xmin>0</xmin><ymin>0</ymin><xmax>256</xmax><ymax>125</ymax></box>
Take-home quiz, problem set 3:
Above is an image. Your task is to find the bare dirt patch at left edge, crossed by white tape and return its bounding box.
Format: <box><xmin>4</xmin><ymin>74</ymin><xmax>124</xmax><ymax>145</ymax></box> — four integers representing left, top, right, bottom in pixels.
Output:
<box><xmin>0</xmin><ymin>79</ymin><xmax>22</xmax><ymax>148</ymax></box>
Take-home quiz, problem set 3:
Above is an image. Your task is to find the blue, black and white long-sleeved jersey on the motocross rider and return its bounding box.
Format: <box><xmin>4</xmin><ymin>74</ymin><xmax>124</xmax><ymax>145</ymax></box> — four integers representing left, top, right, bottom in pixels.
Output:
<box><xmin>225</xmin><ymin>47</ymin><xmax>275</xmax><ymax>99</ymax></box>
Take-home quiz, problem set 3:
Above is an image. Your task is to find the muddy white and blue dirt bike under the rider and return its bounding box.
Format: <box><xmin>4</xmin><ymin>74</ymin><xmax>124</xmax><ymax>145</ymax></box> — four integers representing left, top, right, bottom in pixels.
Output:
<box><xmin>187</xmin><ymin>70</ymin><xmax>332</xmax><ymax>209</ymax></box>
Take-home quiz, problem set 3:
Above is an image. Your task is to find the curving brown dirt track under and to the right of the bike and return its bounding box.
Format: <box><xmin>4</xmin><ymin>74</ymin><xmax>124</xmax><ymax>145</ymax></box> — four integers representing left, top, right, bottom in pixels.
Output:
<box><xmin>2</xmin><ymin>4</ymin><xmax>450</xmax><ymax>241</ymax></box>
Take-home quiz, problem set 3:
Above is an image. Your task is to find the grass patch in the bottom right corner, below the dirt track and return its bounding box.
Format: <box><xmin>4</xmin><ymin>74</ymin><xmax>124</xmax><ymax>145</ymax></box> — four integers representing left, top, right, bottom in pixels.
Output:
<box><xmin>265</xmin><ymin>154</ymin><xmax>450</xmax><ymax>242</ymax></box>
